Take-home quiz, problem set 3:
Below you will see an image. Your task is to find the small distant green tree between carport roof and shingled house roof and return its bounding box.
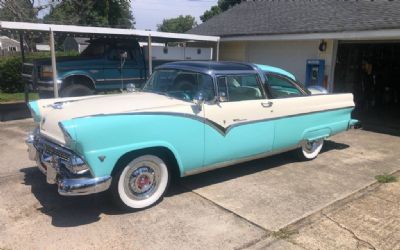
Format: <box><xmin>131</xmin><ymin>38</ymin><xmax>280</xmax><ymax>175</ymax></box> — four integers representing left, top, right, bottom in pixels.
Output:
<box><xmin>157</xmin><ymin>15</ymin><xmax>197</xmax><ymax>33</ymax></box>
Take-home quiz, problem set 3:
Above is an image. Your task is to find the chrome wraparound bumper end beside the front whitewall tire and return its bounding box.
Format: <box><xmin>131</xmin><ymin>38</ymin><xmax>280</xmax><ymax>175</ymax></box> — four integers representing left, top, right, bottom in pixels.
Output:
<box><xmin>58</xmin><ymin>176</ymin><xmax>112</xmax><ymax>196</ymax></box>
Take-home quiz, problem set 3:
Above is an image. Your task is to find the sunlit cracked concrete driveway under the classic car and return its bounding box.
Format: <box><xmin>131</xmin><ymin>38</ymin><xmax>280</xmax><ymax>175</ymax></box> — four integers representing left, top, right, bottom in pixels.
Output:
<box><xmin>0</xmin><ymin>120</ymin><xmax>400</xmax><ymax>249</ymax></box>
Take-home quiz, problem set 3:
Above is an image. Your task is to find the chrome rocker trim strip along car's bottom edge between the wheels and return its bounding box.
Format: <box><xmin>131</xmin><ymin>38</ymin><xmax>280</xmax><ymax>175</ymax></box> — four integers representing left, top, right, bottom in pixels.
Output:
<box><xmin>183</xmin><ymin>144</ymin><xmax>303</xmax><ymax>177</ymax></box>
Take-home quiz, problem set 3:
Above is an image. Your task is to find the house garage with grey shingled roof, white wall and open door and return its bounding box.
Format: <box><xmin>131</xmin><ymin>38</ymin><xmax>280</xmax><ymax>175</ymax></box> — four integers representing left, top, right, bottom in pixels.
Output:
<box><xmin>189</xmin><ymin>0</ymin><xmax>400</xmax><ymax>134</ymax></box>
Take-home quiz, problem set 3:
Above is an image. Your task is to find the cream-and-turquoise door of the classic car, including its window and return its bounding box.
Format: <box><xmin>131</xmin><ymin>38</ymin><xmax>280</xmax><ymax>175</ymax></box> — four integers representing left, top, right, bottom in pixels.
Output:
<box><xmin>204</xmin><ymin>73</ymin><xmax>274</xmax><ymax>166</ymax></box>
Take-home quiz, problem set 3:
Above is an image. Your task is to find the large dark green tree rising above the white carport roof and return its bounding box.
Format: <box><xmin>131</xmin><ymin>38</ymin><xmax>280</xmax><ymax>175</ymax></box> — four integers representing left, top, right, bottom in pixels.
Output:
<box><xmin>43</xmin><ymin>0</ymin><xmax>135</xmax><ymax>28</ymax></box>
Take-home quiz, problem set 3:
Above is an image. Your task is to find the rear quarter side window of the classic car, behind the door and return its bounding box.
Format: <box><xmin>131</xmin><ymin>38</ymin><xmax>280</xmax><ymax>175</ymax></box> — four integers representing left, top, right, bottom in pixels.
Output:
<box><xmin>267</xmin><ymin>75</ymin><xmax>304</xmax><ymax>98</ymax></box>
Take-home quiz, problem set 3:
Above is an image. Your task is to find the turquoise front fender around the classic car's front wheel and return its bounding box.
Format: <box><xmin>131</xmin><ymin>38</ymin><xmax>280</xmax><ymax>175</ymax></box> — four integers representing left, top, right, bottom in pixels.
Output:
<box><xmin>62</xmin><ymin>113</ymin><xmax>204</xmax><ymax>176</ymax></box>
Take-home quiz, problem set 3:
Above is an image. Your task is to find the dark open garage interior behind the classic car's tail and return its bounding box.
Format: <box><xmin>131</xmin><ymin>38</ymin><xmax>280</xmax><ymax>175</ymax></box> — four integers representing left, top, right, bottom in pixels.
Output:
<box><xmin>333</xmin><ymin>41</ymin><xmax>400</xmax><ymax>135</ymax></box>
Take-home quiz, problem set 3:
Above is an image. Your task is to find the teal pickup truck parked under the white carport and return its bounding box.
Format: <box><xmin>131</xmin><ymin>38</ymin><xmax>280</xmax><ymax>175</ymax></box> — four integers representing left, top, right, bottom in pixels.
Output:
<box><xmin>22</xmin><ymin>39</ymin><xmax>161</xmax><ymax>97</ymax></box>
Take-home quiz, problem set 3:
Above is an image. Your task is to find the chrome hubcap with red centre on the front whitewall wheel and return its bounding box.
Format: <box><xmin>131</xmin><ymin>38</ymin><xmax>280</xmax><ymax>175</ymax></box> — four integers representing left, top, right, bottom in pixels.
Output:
<box><xmin>124</xmin><ymin>163</ymin><xmax>160</xmax><ymax>200</ymax></box>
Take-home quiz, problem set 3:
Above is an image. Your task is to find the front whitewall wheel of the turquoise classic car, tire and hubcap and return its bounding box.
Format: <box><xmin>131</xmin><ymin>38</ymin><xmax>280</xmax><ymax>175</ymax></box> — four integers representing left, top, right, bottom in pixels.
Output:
<box><xmin>111</xmin><ymin>155</ymin><xmax>170</xmax><ymax>210</ymax></box>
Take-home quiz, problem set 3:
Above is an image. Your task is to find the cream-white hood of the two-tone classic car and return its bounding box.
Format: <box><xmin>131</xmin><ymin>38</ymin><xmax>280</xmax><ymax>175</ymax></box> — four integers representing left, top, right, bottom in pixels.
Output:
<box><xmin>30</xmin><ymin>92</ymin><xmax>192</xmax><ymax>143</ymax></box>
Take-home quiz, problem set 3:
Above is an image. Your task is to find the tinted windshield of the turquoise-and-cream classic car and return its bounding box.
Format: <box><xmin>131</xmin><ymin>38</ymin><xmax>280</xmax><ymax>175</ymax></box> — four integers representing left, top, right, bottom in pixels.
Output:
<box><xmin>143</xmin><ymin>69</ymin><xmax>215</xmax><ymax>101</ymax></box>
